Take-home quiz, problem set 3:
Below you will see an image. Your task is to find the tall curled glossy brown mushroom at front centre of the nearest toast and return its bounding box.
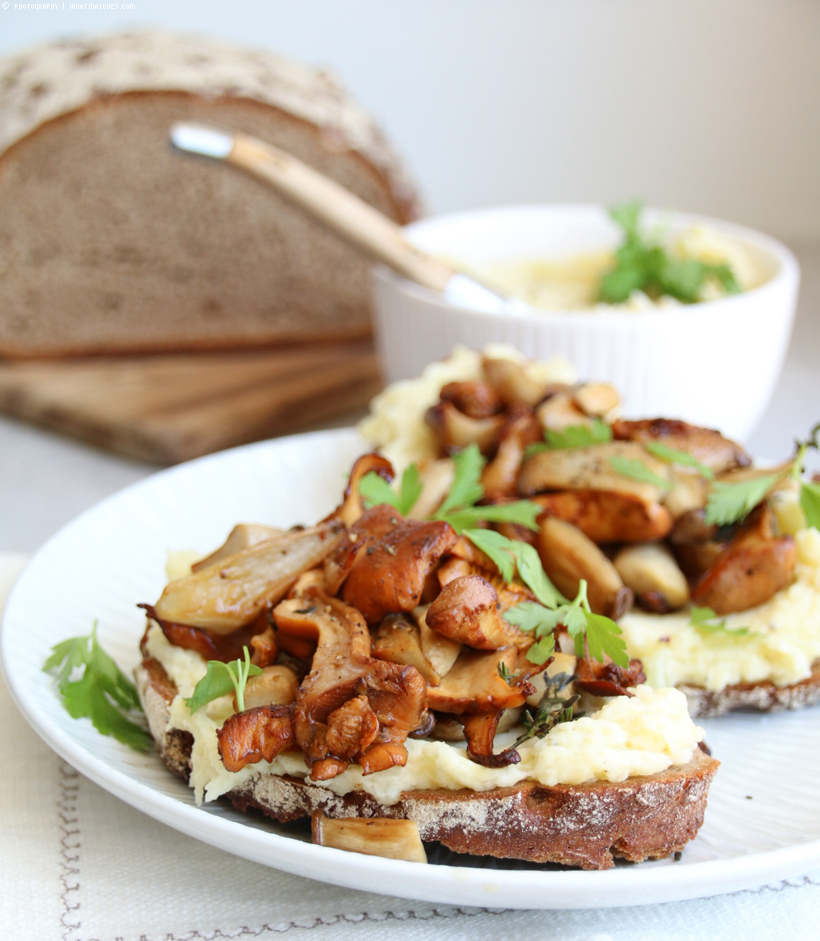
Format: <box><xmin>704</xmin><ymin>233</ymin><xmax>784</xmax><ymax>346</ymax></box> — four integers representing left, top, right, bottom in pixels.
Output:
<box><xmin>274</xmin><ymin>592</ymin><xmax>427</xmax><ymax>781</ymax></box>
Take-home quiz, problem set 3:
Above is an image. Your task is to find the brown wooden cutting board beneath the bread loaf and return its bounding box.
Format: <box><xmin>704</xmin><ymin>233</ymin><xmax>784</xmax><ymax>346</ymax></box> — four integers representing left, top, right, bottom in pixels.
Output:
<box><xmin>0</xmin><ymin>341</ymin><xmax>381</xmax><ymax>464</ymax></box>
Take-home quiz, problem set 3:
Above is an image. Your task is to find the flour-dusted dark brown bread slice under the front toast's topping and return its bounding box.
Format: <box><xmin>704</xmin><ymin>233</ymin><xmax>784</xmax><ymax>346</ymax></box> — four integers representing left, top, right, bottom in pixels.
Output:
<box><xmin>136</xmin><ymin>658</ymin><xmax>719</xmax><ymax>869</ymax></box>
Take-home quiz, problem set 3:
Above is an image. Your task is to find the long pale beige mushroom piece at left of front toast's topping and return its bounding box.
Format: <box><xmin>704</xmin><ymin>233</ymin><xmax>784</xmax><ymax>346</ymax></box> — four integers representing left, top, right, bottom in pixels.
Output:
<box><xmin>154</xmin><ymin>521</ymin><xmax>347</xmax><ymax>634</ymax></box>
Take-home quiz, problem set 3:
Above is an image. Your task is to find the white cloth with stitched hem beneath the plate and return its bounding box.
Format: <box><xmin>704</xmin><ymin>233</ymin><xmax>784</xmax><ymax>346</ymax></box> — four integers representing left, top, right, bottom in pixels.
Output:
<box><xmin>0</xmin><ymin>554</ymin><xmax>820</xmax><ymax>941</ymax></box>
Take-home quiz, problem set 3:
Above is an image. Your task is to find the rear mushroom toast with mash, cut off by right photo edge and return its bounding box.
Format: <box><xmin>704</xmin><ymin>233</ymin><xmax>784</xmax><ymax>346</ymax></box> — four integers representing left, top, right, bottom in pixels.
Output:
<box><xmin>361</xmin><ymin>349</ymin><xmax>820</xmax><ymax>716</ymax></box>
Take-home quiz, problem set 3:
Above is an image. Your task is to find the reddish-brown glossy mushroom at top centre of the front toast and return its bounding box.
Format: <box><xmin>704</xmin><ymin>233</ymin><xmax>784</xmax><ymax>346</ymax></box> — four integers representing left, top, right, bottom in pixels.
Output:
<box><xmin>342</xmin><ymin>505</ymin><xmax>456</xmax><ymax>624</ymax></box>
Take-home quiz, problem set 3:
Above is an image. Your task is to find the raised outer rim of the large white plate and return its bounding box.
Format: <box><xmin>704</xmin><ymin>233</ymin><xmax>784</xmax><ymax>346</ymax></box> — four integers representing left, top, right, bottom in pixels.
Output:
<box><xmin>0</xmin><ymin>428</ymin><xmax>820</xmax><ymax>910</ymax></box>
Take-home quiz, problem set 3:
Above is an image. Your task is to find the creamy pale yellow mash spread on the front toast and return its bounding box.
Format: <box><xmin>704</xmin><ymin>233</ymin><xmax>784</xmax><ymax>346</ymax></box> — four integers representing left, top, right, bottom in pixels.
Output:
<box><xmin>148</xmin><ymin>625</ymin><xmax>703</xmax><ymax>806</ymax></box>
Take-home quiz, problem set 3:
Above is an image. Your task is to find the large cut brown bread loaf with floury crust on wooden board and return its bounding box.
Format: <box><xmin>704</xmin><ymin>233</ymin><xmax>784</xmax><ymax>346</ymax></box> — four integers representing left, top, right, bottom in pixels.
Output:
<box><xmin>0</xmin><ymin>32</ymin><xmax>415</xmax><ymax>356</ymax></box>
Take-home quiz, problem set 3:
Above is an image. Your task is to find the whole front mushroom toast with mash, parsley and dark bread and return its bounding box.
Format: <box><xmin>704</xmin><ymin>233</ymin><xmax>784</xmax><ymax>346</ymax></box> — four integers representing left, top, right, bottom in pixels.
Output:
<box><xmin>137</xmin><ymin>426</ymin><xmax>718</xmax><ymax>869</ymax></box>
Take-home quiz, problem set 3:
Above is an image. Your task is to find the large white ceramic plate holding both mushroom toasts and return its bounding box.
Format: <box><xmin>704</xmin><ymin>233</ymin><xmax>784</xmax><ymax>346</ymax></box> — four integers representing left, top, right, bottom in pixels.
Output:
<box><xmin>2</xmin><ymin>430</ymin><xmax>820</xmax><ymax>908</ymax></box>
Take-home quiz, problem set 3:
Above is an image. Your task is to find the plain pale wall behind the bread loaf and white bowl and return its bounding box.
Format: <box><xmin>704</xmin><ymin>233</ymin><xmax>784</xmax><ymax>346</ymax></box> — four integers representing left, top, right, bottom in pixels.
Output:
<box><xmin>0</xmin><ymin>0</ymin><xmax>820</xmax><ymax>243</ymax></box>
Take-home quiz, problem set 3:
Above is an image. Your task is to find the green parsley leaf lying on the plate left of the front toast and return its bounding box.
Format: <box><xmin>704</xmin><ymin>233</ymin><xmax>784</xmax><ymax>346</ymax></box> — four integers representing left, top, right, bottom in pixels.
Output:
<box><xmin>43</xmin><ymin>621</ymin><xmax>152</xmax><ymax>751</ymax></box>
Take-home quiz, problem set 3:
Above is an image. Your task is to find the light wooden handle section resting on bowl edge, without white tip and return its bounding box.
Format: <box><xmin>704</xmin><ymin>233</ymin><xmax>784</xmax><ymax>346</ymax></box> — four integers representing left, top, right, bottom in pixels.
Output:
<box><xmin>226</xmin><ymin>134</ymin><xmax>454</xmax><ymax>291</ymax></box>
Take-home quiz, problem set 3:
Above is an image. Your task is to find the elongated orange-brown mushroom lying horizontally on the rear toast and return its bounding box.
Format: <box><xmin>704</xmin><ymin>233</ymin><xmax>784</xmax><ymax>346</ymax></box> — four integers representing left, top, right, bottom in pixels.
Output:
<box><xmin>532</xmin><ymin>490</ymin><xmax>672</xmax><ymax>543</ymax></box>
